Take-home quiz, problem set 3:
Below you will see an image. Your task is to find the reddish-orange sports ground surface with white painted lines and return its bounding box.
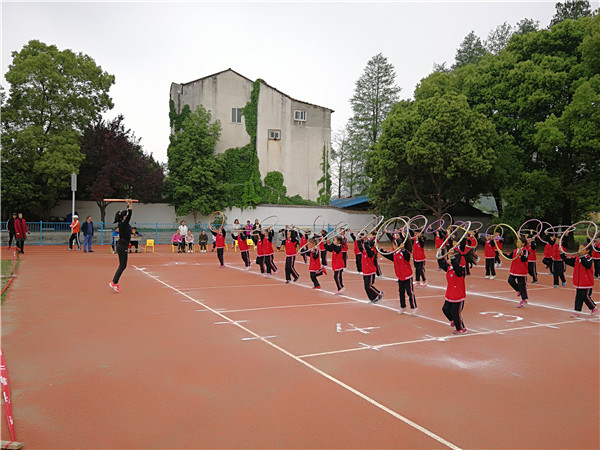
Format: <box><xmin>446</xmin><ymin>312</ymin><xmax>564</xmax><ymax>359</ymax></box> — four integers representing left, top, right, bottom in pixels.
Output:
<box><xmin>2</xmin><ymin>246</ymin><xmax>600</xmax><ymax>449</ymax></box>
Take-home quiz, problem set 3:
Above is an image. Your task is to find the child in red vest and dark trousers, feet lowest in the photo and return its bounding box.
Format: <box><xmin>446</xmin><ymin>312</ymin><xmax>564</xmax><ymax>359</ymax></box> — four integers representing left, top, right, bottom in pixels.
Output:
<box><xmin>440</xmin><ymin>251</ymin><xmax>467</xmax><ymax>334</ymax></box>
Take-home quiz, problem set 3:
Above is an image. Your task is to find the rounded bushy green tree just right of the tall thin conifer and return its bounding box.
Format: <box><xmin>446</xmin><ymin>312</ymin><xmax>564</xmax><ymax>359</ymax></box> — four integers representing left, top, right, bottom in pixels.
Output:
<box><xmin>369</xmin><ymin>93</ymin><xmax>496</xmax><ymax>217</ymax></box>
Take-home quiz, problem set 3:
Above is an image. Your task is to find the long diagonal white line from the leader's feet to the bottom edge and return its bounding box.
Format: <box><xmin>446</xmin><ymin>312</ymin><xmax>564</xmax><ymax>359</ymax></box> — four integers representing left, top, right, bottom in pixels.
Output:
<box><xmin>134</xmin><ymin>266</ymin><xmax>460</xmax><ymax>450</ymax></box>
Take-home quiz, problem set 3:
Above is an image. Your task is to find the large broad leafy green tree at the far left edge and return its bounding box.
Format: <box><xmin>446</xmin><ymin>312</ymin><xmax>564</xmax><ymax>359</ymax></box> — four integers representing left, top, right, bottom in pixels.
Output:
<box><xmin>2</xmin><ymin>40</ymin><xmax>114</xmax><ymax>214</ymax></box>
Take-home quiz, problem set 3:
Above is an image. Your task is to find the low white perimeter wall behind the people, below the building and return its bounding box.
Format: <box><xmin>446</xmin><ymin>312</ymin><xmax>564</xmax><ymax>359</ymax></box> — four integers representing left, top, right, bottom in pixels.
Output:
<box><xmin>50</xmin><ymin>200</ymin><xmax>373</xmax><ymax>229</ymax></box>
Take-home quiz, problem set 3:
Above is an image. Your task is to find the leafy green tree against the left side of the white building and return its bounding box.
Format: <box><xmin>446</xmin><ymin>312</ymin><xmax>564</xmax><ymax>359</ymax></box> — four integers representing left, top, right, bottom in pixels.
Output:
<box><xmin>166</xmin><ymin>106</ymin><xmax>226</xmax><ymax>220</ymax></box>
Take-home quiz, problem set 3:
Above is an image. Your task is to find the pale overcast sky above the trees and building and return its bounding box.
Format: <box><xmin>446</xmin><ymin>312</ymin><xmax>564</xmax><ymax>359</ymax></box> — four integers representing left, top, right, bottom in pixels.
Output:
<box><xmin>1</xmin><ymin>0</ymin><xmax>568</xmax><ymax>162</ymax></box>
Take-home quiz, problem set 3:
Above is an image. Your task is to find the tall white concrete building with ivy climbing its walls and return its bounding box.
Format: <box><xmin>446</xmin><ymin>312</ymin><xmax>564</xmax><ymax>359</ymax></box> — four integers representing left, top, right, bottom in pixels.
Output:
<box><xmin>170</xmin><ymin>69</ymin><xmax>333</xmax><ymax>200</ymax></box>
